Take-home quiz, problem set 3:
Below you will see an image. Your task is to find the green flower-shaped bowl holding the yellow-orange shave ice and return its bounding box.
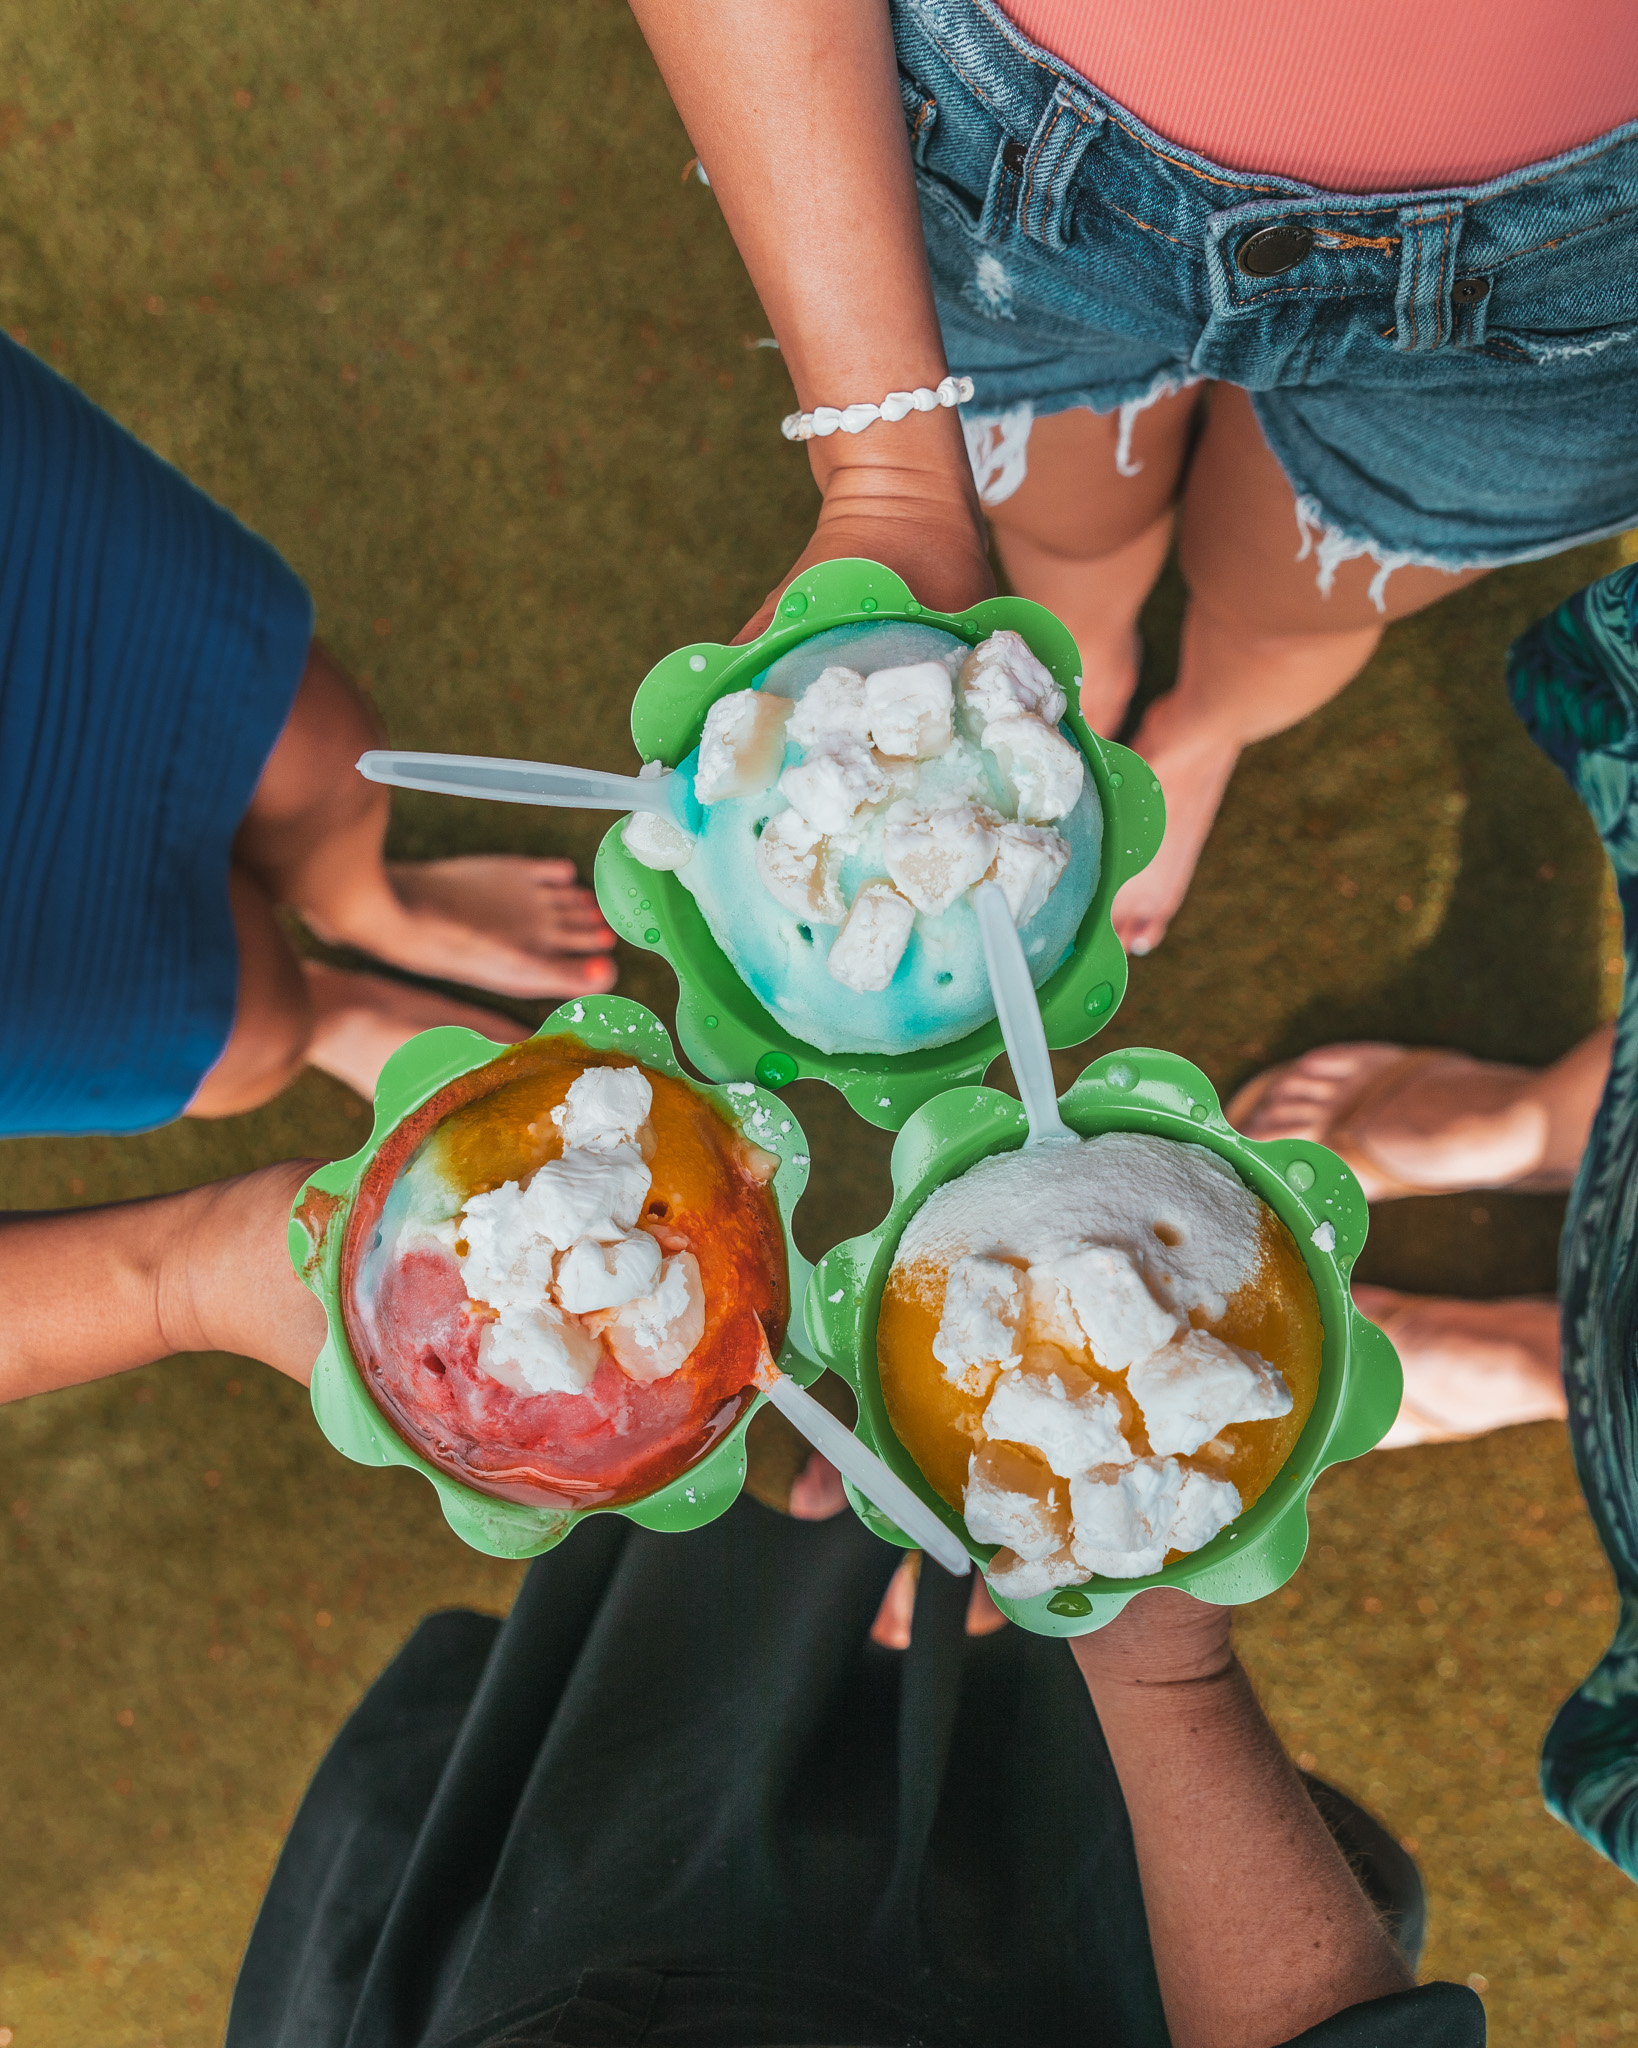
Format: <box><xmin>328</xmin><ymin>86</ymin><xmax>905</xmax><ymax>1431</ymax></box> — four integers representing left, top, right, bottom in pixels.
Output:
<box><xmin>807</xmin><ymin>1049</ymin><xmax>1400</xmax><ymax>1636</ymax></box>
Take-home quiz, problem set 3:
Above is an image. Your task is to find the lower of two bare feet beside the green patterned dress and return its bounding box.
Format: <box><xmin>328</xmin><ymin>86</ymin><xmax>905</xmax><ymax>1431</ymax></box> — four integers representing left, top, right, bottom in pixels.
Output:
<box><xmin>1353</xmin><ymin>1282</ymin><xmax>1568</xmax><ymax>1450</ymax></box>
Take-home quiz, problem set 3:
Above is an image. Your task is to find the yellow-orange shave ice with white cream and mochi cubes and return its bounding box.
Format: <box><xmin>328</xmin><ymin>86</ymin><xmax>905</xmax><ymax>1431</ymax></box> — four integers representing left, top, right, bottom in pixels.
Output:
<box><xmin>876</xmin><ymin>1130</ymin><xmax>1325</xmax><ymax>1599</ymax></box>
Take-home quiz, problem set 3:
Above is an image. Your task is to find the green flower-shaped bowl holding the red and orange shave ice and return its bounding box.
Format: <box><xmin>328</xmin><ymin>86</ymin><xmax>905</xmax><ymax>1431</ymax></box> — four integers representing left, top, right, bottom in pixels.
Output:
<box><xmin>291</xmin><ymin>995</ymin><xmax>821</xmax><ymax>1556</ymax></box>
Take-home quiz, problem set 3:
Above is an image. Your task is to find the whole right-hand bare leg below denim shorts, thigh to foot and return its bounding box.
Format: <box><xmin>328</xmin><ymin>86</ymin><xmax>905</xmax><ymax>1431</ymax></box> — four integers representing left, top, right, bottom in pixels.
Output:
<box><xmin>1114</xmin><ymin>385</ymin><xmax>1484</xmax><ymax>952</ymax></box>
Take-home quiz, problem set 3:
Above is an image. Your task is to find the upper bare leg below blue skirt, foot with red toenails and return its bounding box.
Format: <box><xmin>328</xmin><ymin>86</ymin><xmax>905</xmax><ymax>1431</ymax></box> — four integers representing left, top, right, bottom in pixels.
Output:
<box><xmin>233</xmin><ymin>641</ymin><xmax>614</xmax><ymax>995</ymax></box>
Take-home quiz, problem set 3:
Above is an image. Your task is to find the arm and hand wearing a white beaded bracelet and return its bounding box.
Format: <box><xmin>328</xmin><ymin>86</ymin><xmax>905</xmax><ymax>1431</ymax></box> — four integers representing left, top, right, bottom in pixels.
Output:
<box><xmin>633</xmin><ymin>0</ymin><xmax>995</xmax><ymax>635</ymax></box>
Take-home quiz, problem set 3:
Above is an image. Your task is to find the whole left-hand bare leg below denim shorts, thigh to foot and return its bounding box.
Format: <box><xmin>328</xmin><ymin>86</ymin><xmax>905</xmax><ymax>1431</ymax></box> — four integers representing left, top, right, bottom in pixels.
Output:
<box><xmin>991</xmin><ymin>391</ymin><xmax>1200</xmax><ymax>739</ymax></box>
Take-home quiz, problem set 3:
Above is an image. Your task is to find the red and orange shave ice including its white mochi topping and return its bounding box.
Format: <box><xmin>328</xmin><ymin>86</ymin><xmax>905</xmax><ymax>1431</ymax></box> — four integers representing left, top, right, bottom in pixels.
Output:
<box><xmin>342</xmin><ymin>1038</ymin><xmax>788</xmax><ymax>1507</ymax></box>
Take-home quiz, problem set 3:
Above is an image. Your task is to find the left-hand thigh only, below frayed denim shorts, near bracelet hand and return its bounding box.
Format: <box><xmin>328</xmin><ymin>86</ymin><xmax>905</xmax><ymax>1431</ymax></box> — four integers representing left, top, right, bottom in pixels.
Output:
<box><xmin>989</xmin><ymin>385</ymin><xmax>1200</xmax><ymax>561</ymax></box>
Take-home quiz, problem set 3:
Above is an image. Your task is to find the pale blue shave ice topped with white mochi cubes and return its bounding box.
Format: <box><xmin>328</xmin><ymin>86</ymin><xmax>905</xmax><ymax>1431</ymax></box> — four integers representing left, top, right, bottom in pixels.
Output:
<box><xmin>624</xmin><ymin>621</ymin><xmax>1104</xmax><ymax>1053</ymax></box>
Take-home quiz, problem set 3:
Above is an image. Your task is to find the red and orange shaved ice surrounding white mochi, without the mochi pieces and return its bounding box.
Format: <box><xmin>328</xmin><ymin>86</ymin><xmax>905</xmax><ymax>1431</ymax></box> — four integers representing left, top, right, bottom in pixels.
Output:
<box><xmin>342</xmin><ymin>1038</ymin><xmax>788</xmax><ymax>1507</ymax></box>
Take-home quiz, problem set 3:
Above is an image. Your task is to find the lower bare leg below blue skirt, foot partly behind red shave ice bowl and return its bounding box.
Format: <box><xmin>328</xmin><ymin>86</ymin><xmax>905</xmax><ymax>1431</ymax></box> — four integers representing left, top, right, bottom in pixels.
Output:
<box><xmin>184</xmin><ymin>864</ymin><xmax>526</xmax><ymax>1116</ymax></box>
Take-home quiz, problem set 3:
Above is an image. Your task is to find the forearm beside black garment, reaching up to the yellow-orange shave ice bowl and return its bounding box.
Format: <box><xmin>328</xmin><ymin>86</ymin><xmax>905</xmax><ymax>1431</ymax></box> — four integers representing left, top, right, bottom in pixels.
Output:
<box><xmin>1073</xmin><ymin>1589</ymin><xmax>1411</xmax><ymax>2048</ymax></box>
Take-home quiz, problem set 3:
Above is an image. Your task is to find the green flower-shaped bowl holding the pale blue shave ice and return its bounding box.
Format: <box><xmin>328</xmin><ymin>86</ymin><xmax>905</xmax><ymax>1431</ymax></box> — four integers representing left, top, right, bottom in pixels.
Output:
<box><xmin>596</xmin><ymin>561</ymin><xmax>1165</xmax><ymax>1130</ymax></box>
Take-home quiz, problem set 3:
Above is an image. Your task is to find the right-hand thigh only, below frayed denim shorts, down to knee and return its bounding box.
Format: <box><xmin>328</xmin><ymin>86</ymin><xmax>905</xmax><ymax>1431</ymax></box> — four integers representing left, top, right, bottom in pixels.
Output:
<box><xmin>1177</xmin><ymin>383</ymin><xmax>1486</xmax><ymax>635</ymax></box>
